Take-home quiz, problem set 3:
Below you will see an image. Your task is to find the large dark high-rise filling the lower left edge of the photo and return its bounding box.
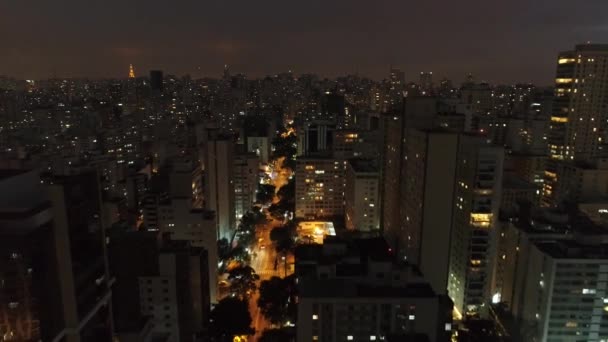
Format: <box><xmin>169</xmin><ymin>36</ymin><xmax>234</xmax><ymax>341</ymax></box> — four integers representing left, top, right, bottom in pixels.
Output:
<box><xmin>0</xmin><ymin>170</ymin><xmax>113</xmax><ymax>342</ymax></box>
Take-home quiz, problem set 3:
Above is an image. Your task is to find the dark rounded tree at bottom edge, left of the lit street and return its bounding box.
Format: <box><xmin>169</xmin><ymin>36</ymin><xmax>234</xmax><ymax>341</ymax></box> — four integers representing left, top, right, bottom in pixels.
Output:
<box><xmin>209</xmin><ymin>297</ymin><xmax>255</xmax><ymax>342</ymax></box>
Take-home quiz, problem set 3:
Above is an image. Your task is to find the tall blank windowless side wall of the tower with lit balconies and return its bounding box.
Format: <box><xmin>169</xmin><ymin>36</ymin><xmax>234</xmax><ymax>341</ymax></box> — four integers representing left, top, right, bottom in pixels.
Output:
<box><xmin>420</xmin><ymin>134</ymin><xmax>458</xmax><ymax>293</ymax></box>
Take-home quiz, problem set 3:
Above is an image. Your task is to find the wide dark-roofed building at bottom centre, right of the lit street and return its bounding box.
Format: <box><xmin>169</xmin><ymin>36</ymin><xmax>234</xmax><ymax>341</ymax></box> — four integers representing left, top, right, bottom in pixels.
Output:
<box><xmin>295</xmin><ymin>237</ymin><xmax>452</xmax><ymax>341</ymax></box>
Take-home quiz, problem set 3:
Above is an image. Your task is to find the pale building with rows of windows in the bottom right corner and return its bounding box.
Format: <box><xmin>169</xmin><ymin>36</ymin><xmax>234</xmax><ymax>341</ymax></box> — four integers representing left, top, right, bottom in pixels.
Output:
<box><xmin>514</xmin><ymin>240</ymin><xmax>608</xmax><ymax>341</ymax></box>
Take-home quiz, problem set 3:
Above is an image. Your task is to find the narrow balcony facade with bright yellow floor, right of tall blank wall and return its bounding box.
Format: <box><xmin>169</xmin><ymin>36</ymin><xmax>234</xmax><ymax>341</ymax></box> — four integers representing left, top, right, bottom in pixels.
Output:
<box><xmin>448</xmin><ymin>136</ymin><xmax>504</xmax><ymax>315</ymax></box>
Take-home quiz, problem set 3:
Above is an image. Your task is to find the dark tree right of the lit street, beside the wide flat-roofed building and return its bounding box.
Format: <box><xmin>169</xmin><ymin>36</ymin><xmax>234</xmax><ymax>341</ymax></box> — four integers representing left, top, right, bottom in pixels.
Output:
<box><xmin>257</xmin><ymin>277</ymin><xmax>291</xmax><ymax>324</ymax></box>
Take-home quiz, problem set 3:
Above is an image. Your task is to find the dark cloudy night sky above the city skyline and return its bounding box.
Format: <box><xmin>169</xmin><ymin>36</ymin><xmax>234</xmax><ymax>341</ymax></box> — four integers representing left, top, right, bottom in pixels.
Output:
<box><xmin>0</xmin><ymin>0</ymin><xmax>608</xmax><ymax>84</ymax></box>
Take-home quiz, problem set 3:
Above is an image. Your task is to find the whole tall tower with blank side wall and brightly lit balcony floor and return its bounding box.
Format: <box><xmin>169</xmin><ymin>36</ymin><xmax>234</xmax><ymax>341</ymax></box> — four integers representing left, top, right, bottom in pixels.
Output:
<box><xmin>392</xmin><ymin>129</ymin><xmax>503</xmax><ymax>313</ymax></box>
